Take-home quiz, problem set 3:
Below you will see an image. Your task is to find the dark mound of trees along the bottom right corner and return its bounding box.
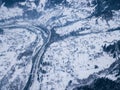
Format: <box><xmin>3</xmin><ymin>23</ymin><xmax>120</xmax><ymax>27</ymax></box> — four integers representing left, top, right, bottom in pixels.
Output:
<box><xmin>73</xmin><ymin>78</ymin><xmax>120</xmax><ymax>90</ymax></box>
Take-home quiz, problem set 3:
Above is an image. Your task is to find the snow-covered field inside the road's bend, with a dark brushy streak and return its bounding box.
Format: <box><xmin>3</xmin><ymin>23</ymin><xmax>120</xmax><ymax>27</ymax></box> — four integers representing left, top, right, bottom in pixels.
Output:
<box><xmin>0</xmin><ymin>26</ymin><xmax>42</xmax><ymax>90</ymax></box>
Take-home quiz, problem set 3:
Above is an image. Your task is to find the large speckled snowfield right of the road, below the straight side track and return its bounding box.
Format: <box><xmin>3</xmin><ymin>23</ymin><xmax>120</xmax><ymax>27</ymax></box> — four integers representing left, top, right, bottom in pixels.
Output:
<box><xmin>39</xmin><ymin>31</ymin><xmax>120</xmax><ymax>90</ymax></box>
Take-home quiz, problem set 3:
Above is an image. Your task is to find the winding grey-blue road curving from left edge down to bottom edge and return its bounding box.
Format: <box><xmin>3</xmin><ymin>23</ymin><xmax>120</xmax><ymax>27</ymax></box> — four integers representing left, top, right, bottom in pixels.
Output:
<box><xmin>0</xmin><ymin>20</ymin><xmax>51</xmax><ymax>90</ymax></box>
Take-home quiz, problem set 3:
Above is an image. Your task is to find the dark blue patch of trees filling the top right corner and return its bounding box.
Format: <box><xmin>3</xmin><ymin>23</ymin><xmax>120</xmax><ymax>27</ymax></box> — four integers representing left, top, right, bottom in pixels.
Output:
<box><xmin>93</xmin><ymin>0</ymin><xmax>120</xmax><ymax>19</ymax></box>
